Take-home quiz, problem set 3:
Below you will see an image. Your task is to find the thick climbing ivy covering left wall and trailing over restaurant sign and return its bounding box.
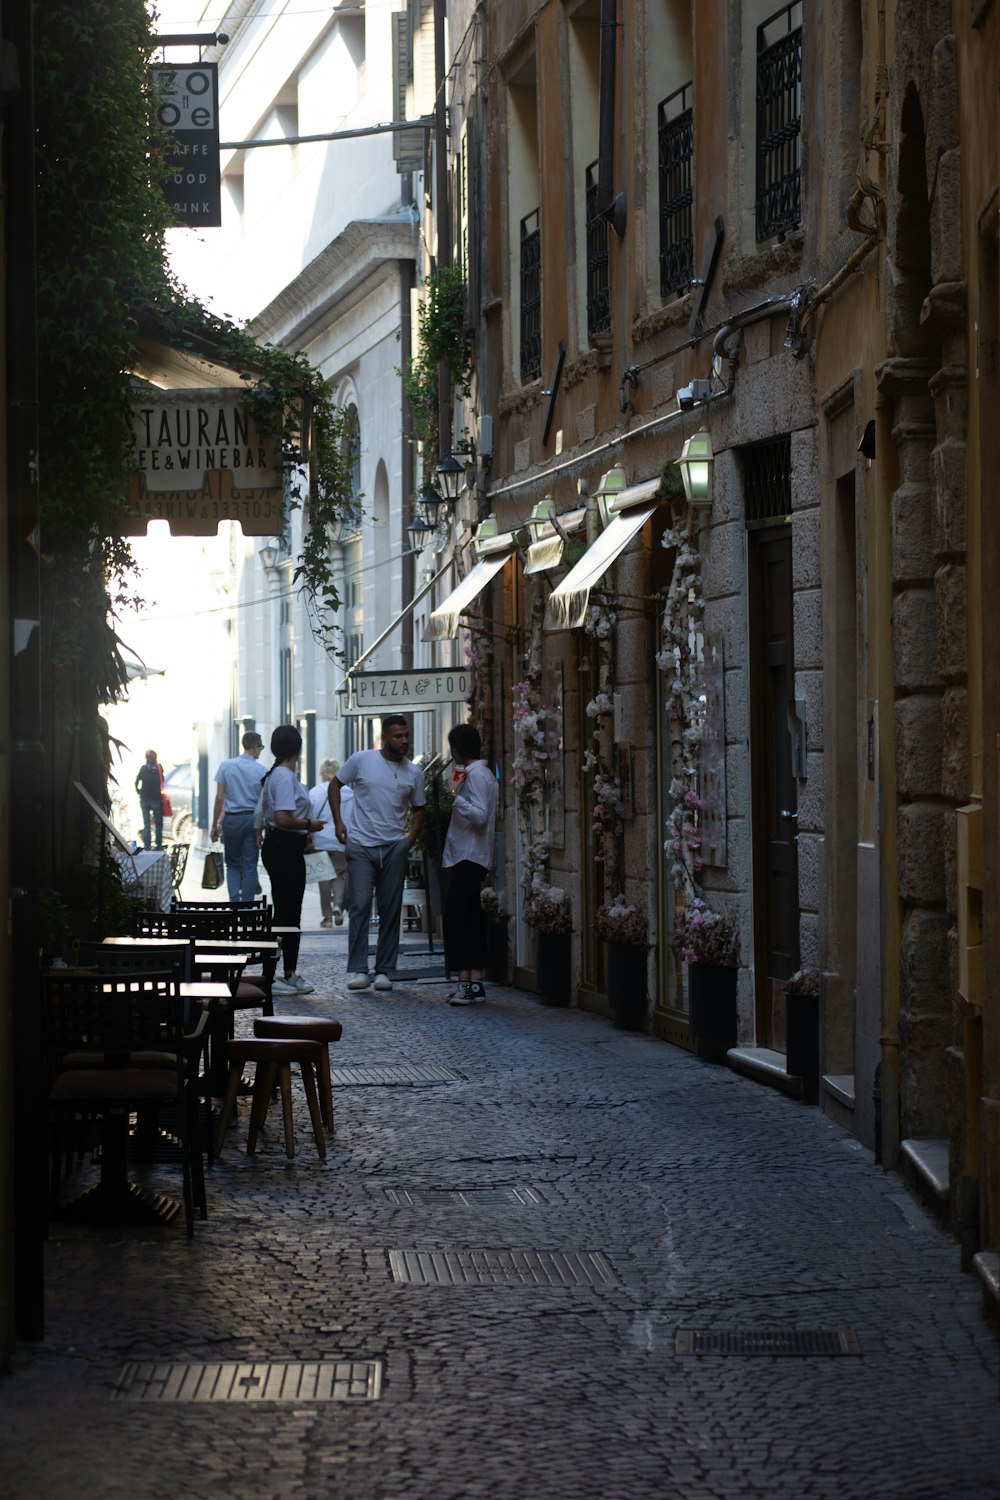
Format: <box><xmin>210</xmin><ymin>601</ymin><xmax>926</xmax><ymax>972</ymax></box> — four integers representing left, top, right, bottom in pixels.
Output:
<box><xmin>34</xmin><ymin>0</ymin><xmax>357</xmax><ymax>731</ymax></box>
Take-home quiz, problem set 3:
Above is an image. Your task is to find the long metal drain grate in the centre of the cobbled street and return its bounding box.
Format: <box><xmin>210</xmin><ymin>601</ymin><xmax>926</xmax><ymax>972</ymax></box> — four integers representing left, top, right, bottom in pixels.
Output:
<box><xmin>388</xmin><ymin>1250</ymin><xmax>618</xmax><ymax>1287</ymax></box>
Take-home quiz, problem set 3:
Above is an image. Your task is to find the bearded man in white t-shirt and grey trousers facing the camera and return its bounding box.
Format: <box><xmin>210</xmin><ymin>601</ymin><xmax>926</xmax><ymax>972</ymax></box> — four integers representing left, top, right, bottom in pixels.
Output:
<box><xmin>327</xmin><ymin>714</ymin><xmax>424</xmax><ymax>990</ymax></box>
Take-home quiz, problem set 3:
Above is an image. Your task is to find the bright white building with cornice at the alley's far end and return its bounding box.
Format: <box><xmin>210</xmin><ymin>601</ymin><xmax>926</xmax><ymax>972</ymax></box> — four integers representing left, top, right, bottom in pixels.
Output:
<box><xmin>160</xmin><ymin>0</ymin><xmax>462</xmax><ymax>782</ymax></box>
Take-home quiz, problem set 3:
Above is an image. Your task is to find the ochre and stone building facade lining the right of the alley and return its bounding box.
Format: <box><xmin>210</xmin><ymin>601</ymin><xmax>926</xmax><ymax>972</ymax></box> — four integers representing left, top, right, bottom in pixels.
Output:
<box><xmin>413</xmin><ymin>0</ymin><xmax>1000</xmax><ymax>1290</ymax></box>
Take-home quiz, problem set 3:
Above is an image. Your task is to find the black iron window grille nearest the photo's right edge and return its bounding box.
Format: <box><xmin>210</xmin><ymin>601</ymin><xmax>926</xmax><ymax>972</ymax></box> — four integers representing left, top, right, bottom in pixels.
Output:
<box><xmin>757</xmin><ymin>0</ymin><xmax>802</xmax><ymax>240</ymax></box>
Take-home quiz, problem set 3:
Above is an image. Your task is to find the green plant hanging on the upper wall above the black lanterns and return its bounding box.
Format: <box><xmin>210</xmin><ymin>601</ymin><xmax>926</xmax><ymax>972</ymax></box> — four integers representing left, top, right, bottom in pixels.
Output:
<box><xmin>405</xmin><ymin>266</ymin><xmax>471</xmax><ymax>473</ymax></box>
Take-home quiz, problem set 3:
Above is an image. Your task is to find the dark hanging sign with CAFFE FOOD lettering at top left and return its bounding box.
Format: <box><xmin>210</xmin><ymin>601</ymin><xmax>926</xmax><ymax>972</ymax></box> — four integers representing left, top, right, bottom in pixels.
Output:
<box><xmin>150</xmin><ymin>63</ymin><xmax>222</xmax><ymax>230</ymax></box>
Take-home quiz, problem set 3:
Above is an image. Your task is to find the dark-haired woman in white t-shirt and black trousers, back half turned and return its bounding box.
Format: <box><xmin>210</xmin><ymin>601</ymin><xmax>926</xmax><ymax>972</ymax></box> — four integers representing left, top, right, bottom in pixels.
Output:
<box><xmin>261</xmin><ymin>725</ymin><xmax>322</xmax><ymax>995</ymax></box>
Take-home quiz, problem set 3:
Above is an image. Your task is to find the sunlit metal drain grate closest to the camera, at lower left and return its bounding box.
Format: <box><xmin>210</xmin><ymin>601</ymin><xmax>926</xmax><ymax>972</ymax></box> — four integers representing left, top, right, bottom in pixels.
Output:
<box><xmin>111</xmin><ymin>1359</ymin><xmax>382</xmax><ymax>1403</ymax></box>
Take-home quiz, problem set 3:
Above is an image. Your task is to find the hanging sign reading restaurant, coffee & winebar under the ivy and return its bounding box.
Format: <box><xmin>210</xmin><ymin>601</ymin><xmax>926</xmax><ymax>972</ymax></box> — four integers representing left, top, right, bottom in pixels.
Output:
<box><xmin>123</xmin><ymin>390</ymin><xmax>283</xmax><ymax>537</ymax></box>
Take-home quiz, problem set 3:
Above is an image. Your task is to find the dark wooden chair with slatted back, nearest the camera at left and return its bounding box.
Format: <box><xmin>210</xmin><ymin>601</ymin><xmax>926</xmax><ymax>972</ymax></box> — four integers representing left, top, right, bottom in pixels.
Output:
<box><xmin>43</xmin><ymin>968</ymin><xmax>207</xmax><ymax>1236</ymax></box>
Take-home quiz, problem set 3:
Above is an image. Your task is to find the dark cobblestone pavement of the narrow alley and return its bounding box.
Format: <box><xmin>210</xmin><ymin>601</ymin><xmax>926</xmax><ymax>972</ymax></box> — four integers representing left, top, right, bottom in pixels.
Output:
<box><xmin>0</xmin><ymin>921</ymin><xmax>1000</xmax><ymax>1500</ymax></box>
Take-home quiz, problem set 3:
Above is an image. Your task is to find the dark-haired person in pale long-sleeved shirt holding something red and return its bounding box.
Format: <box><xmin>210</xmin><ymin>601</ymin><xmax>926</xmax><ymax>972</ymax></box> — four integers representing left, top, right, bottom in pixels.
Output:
<box><xmin>441</xmin><ymin>725</ymin><xmax>496</xmax><ymax>1005</ymax></box>
